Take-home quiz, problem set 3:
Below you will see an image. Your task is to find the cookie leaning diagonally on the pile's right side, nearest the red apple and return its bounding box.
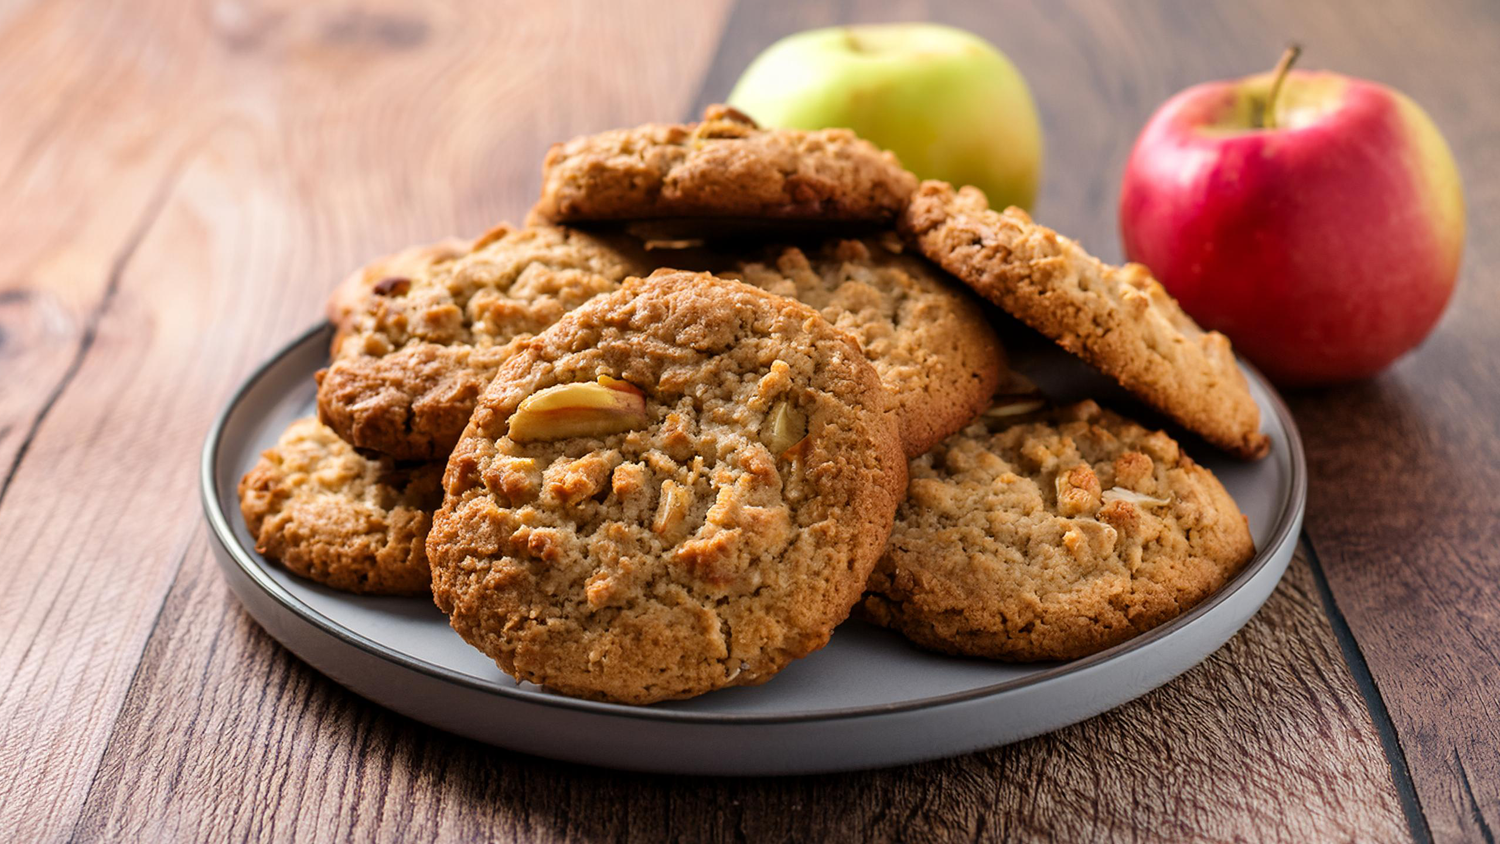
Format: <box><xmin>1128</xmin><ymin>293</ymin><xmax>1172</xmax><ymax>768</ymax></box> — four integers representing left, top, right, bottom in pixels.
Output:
<box><xmin>900</xmin><ymin>181</ymin><xmax>1271</xmax><ymax>459</ymax></box>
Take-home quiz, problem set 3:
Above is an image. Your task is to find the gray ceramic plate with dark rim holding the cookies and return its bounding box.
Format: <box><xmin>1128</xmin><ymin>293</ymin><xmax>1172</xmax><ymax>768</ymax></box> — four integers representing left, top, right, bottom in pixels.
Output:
<box><xmin>203</xmin><ymin>327</ymin><xmax>1307</xmax><ymax>775</ymax></box>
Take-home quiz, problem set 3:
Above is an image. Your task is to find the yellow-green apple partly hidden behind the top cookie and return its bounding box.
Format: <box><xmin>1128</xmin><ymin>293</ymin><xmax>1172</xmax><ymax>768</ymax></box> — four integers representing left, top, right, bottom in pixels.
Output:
<box><xmin>729</xmin><ymin>24</ymin><xmax>1041</xmax><ymax>208</ymax></box>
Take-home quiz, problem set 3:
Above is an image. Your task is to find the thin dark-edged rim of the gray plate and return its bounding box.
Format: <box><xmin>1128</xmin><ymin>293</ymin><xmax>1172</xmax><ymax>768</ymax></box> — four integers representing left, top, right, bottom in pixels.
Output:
<box><xmin>198</xmin><ymin>321</ymin><xmax>1308</xmax><ymax>726</ymax></box>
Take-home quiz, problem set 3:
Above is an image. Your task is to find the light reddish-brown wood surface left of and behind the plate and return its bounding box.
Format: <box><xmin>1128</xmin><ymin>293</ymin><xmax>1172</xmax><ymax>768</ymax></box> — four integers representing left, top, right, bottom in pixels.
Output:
<box><xmin>0</xmin><ymin>0</ymin><xmax>725</xmax><ymax>840</ymax></box>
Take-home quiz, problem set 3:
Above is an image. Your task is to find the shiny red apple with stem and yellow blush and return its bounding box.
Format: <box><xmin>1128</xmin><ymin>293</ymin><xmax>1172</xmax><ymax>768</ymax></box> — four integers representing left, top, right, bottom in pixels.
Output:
<box><xmin>1121</xmin><ymin>49</ymin><xmax>1464</xmax><ymax>385</ymax></box>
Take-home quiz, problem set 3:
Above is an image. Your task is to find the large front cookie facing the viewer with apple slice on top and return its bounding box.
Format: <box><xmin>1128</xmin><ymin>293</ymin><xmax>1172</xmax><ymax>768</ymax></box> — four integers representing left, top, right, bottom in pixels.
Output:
<box><xmin>428</xmin><ymin>271</ymin><xmax>906</xmax><ymax>705</ymax></box>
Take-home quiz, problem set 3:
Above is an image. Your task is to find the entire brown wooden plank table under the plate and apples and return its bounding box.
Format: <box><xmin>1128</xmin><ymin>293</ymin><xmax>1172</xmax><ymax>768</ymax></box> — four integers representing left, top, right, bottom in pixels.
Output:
<box><xmin>0</xmin><ymin>0</ymin><xmax>1500</xmax><ymax>843</ymax></box>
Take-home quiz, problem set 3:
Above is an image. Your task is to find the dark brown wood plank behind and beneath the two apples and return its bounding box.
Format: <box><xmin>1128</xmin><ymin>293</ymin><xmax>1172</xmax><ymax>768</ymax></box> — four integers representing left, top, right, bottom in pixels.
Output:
<box><xmin>704</xmin><ymin>0</ymin><xmax>1500</xmax><ymax>840</ymax></box>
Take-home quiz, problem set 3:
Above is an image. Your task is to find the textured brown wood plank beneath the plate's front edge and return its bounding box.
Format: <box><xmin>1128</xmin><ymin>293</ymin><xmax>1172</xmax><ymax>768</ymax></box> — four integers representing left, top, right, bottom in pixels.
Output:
<box><xmin>75</xmin><ymin>538</ymin><xmax>1406</xmax><ymax>843</ymax></box>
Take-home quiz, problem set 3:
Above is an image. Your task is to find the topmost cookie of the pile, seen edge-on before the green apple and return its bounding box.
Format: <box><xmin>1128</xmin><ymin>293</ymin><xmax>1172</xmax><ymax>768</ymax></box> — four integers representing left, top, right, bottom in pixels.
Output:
<box><xmin>533</xmin><ymin>105</ymin><xmax>917</xmax><ymax>226</ymax></box>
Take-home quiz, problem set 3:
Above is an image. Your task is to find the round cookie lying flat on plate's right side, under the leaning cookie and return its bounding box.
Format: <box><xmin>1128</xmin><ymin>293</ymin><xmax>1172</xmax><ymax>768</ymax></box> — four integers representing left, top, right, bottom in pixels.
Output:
<box><xmin>863</xmin><ymin>402</ymin><xmax>1254</xmax><ymax>661</ymax></box>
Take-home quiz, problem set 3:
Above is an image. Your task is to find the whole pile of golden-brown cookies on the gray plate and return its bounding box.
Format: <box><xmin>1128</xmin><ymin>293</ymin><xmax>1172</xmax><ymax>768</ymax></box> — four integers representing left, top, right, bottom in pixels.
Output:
<box><xmin>240</xmin><ymin>106</ymin><xmax>1268</xmax><ymax>703</ymax></box>
